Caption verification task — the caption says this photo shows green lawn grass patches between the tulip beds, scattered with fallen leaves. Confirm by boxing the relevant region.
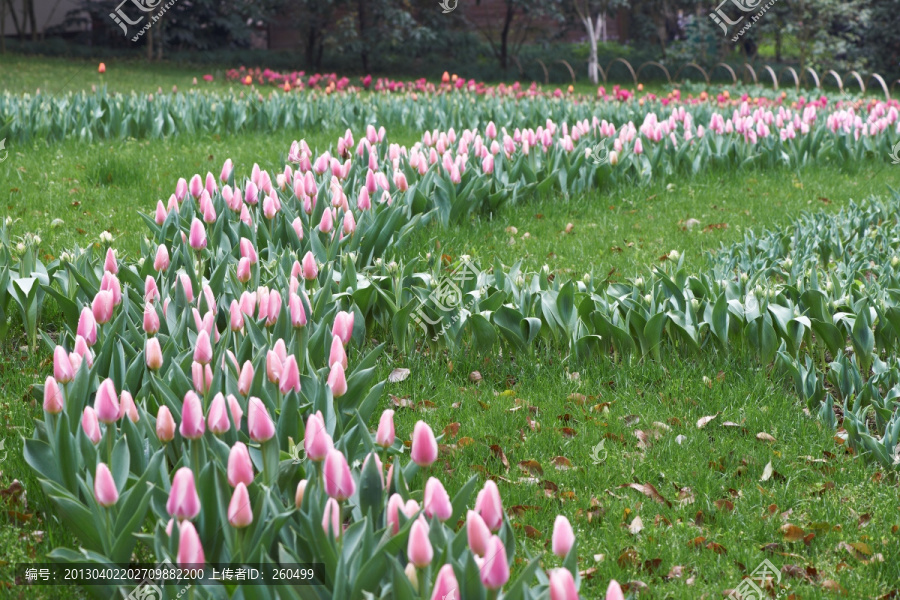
[0,57,900,599]
